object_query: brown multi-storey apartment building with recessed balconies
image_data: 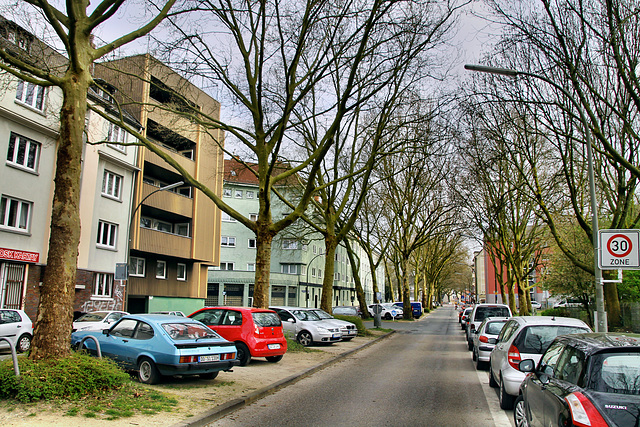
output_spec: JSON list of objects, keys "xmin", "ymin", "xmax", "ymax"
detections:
[{"xmin": 95, "ymin": 55, "xmax": 224, "ymax": 313}]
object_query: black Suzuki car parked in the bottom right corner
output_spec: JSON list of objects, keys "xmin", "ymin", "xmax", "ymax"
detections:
[{"xmin": 513, "ymin": 333, "xmax": 640, "ymax": 426}]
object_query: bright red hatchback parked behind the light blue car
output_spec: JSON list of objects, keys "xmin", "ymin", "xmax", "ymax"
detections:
[{"xmin": 188, "ymin": 307, "xmax": 287, "ymax": 366}]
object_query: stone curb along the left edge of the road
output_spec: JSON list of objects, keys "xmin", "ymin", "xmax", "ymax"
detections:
[{"xmin": 172, "ymin": 331, "xmax": 396, "ymax": 427}]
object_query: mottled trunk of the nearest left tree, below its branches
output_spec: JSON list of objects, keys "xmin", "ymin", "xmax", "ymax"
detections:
[{"xmin": 30, "ymin": 75, "xmax": 91, "ymax": 360}]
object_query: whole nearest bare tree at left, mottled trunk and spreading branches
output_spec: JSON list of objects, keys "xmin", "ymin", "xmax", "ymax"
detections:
[{"xmin": 0, "ymin": 0, "xmax": 175, "ymax": 359}]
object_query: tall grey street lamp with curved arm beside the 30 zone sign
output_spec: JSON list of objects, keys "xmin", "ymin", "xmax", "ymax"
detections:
[{"xmin": 464, "ymin": 64, "xmax": 608, "ymax": 332}]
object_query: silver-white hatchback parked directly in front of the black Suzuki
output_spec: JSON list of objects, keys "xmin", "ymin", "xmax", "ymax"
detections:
[{"xmin": 489, "ymin": 316, "xmax": 591, "ymax": 409}]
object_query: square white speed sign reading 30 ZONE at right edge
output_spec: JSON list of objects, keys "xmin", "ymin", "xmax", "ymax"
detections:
[{"xmin": 598, "ymin": 230, "xmax": 640, "ymax": 270}]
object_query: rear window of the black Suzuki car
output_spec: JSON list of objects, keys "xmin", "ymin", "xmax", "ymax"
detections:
[{"xmin": 592, "ymin": 353, "xmax": 640, "ymax": 395}]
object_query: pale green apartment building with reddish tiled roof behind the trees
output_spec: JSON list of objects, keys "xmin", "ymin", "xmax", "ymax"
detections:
[{"xmin": 205, "ymin": 160, "xmax": 384, "ymax": 307}]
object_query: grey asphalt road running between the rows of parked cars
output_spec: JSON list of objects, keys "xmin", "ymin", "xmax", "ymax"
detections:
[{"xmin": 209, "ymin": 306, "xmax": 512, "ymax": 427}]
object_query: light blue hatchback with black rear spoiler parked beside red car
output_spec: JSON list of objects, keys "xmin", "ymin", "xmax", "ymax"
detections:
[{"xmin": 71, "ymin": 314, "xmax": 238, "ymax": 384}]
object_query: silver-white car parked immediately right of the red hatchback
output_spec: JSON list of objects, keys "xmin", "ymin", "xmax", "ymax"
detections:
[{"xmin": 269, "ymin": 307, "xmax": 342, "ymax": 347}]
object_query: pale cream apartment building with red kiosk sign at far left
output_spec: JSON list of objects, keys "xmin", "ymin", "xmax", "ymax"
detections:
[{"xmin": 0, "ymin": 18, "xmax": 139, "ymax": 319}]
